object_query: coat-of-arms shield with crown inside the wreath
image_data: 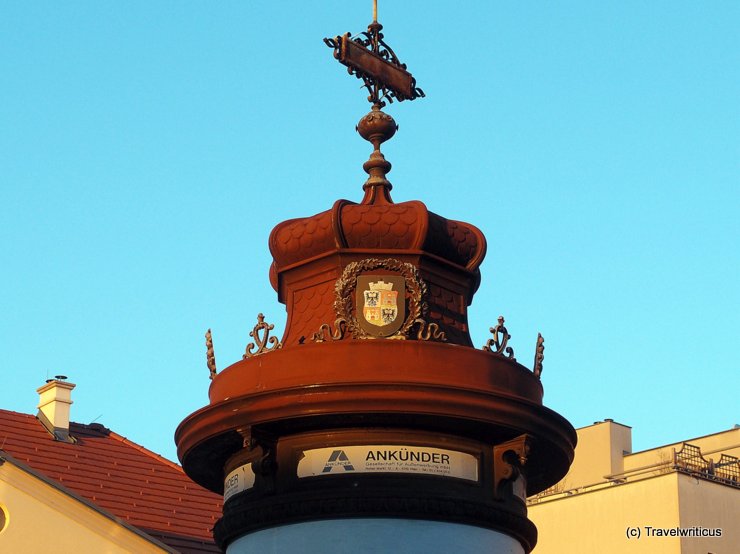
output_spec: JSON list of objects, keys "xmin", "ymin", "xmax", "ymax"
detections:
[{"xmin": 356, "ymin": 275, "xmax": 406, "ymax": 337}]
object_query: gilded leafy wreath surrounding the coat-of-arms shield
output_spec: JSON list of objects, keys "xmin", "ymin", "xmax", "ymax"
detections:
[{"xmin": 334, "ymin": 258, "xmax": 427, "ymax": 340}]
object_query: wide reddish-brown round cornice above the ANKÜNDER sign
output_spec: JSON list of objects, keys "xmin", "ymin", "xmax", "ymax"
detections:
[{"xmin": 175, "ymin": 340, "xmax": 576, "ymax": 493}]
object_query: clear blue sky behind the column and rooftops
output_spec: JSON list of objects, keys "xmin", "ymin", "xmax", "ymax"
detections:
[{"xmin": 0, "ymin": 0, "xmax": 740, "ymax": 458}]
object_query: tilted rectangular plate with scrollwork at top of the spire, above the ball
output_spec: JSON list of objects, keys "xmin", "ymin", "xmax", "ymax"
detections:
[{"xmin": 324, "ymin": 14, "xmax": 424, "ymax": 108}]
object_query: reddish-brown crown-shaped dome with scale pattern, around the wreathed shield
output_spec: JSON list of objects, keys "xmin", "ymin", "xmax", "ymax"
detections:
[{"xmin": 270, "ymin": 194, "xmax": 486, "ymax": 346}]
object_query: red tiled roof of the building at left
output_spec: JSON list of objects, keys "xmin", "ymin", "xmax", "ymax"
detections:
[{"xmin": 0, "ymin": 410, "xmax": 222, "ymax": 554}]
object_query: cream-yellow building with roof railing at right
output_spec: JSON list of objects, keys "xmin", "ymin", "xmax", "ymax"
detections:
[{"xmin": 528, "ymin": 420, "xmax": 740, "ymax": 554}]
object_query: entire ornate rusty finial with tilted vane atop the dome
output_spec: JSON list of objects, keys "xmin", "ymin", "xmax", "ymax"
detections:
[{"xmin": 324, "ymin": 0, "xmax": 424, "ymax": 204}]
